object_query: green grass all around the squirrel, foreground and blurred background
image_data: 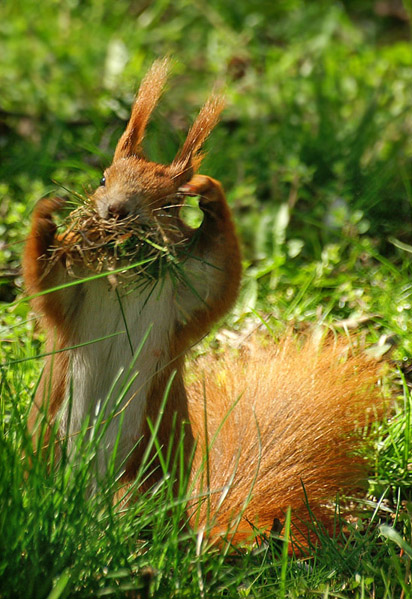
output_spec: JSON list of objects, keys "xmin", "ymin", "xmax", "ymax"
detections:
[{"xmin": 0, "ymin": 0, "xmax": 412, "ymax": 599}]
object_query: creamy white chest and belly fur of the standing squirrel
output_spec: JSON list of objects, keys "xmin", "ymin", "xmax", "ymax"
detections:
[{"xmin": 61, "ymin": 279, "xmax": 175, "ymax": 473}]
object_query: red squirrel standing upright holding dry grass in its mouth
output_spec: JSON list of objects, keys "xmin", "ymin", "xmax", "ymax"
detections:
[{"xmin": 23, "ymin": 60, "xmax": 384, "ymax": 536}]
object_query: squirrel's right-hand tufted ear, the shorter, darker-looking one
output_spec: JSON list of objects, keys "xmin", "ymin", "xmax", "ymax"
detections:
[{"xmin": 172, "ymin": 94, "xmax": 225, "ymax": 172}]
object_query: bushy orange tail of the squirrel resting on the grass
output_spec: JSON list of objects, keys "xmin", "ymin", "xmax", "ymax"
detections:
[{"xmin": 189, "ymin": 338, "xmax": 383, "ymax": 538}]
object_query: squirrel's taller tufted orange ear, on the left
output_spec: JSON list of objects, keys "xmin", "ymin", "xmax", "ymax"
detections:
[{"xmin": 113, "ymin": 58, "xmax": 170, "ymax": 162}]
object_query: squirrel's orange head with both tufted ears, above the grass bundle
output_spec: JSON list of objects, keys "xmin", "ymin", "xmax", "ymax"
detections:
[{"xmin": 91, "ymin": 59, "xmax": 224, "ymax": 220}]
